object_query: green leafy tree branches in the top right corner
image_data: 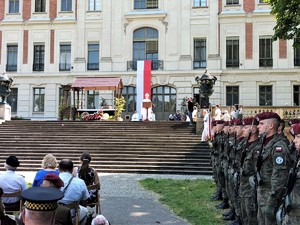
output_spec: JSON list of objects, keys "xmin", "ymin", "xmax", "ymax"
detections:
[{"xmin": 268, "ymin": 0, "xmax": 300, "ymax": 47}]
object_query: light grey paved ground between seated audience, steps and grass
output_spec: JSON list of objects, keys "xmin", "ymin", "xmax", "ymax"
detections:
[{"xmin": 21, "ymin": 172, "xmax": 210, "ymax": 225}]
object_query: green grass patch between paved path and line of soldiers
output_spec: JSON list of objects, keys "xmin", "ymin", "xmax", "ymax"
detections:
[{"xmin": 140, "ymin": 178, "xmax": 226, "ymax": 225}]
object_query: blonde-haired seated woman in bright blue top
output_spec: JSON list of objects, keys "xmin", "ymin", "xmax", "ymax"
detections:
[{"xmin": 32, "ymin": 154, "xmax": 58, "ymax": 187}]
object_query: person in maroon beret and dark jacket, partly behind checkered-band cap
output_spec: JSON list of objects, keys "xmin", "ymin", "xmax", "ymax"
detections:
[{"xmin": 41, "ymin": 174, "xmax": 72, "ymax": 225}]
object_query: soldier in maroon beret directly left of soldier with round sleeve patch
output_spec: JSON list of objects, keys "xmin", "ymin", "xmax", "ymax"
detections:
[{"xmin": 239, "ymin": 117, "xmax": 261, "ymax": 225}]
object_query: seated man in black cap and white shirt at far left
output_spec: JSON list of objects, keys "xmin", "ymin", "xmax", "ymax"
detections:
[{"xmin": 0, "ymin": 155, "xmax": 27, "ymax": 211}]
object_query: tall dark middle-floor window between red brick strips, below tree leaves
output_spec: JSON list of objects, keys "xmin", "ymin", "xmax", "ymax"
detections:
[{"xmin": 259, "ymin": 38, "xmax": 273, "ymax": 67}]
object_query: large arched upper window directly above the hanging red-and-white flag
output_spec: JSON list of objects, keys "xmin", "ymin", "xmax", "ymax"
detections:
[{"xmin": 133, "ymin": 27, "xmax": 160, "ymax": 70}]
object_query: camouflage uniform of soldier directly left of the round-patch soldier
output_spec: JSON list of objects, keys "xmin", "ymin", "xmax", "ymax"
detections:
[{"xmin": 239, "ymin": 139, "xmax": 261, "ymax": 225}]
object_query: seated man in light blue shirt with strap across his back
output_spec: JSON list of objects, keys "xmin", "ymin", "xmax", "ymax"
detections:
[{"xmin": 58, "ymin": 159, "xmax": 90, "ymax": 225}]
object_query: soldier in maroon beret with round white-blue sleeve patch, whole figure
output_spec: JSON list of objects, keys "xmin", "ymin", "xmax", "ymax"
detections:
[{"xmin": 256, "ymin": 112, "xmax": 292, "ymax": 225}]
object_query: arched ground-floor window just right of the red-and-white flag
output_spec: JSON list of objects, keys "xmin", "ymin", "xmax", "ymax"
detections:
[{"xmin": 152, "ymin": 86, "xmax": 176, "ymax": 120}]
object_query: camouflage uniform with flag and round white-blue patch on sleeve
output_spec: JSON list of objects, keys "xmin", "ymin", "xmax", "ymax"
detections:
[{"xmin": 257, "ymin": 134, "xmax": 292, "ymax": 225}]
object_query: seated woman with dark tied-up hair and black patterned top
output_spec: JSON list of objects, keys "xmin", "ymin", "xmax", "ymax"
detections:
[{"xmin": 74, "ymin": 152, "xmax": 100, "ymax": 206}]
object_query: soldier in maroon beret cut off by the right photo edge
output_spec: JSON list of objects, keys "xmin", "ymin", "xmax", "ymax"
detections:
[{"xmin": 282, "ymin": 123, "xmax": 300, "ymax": 225}]
